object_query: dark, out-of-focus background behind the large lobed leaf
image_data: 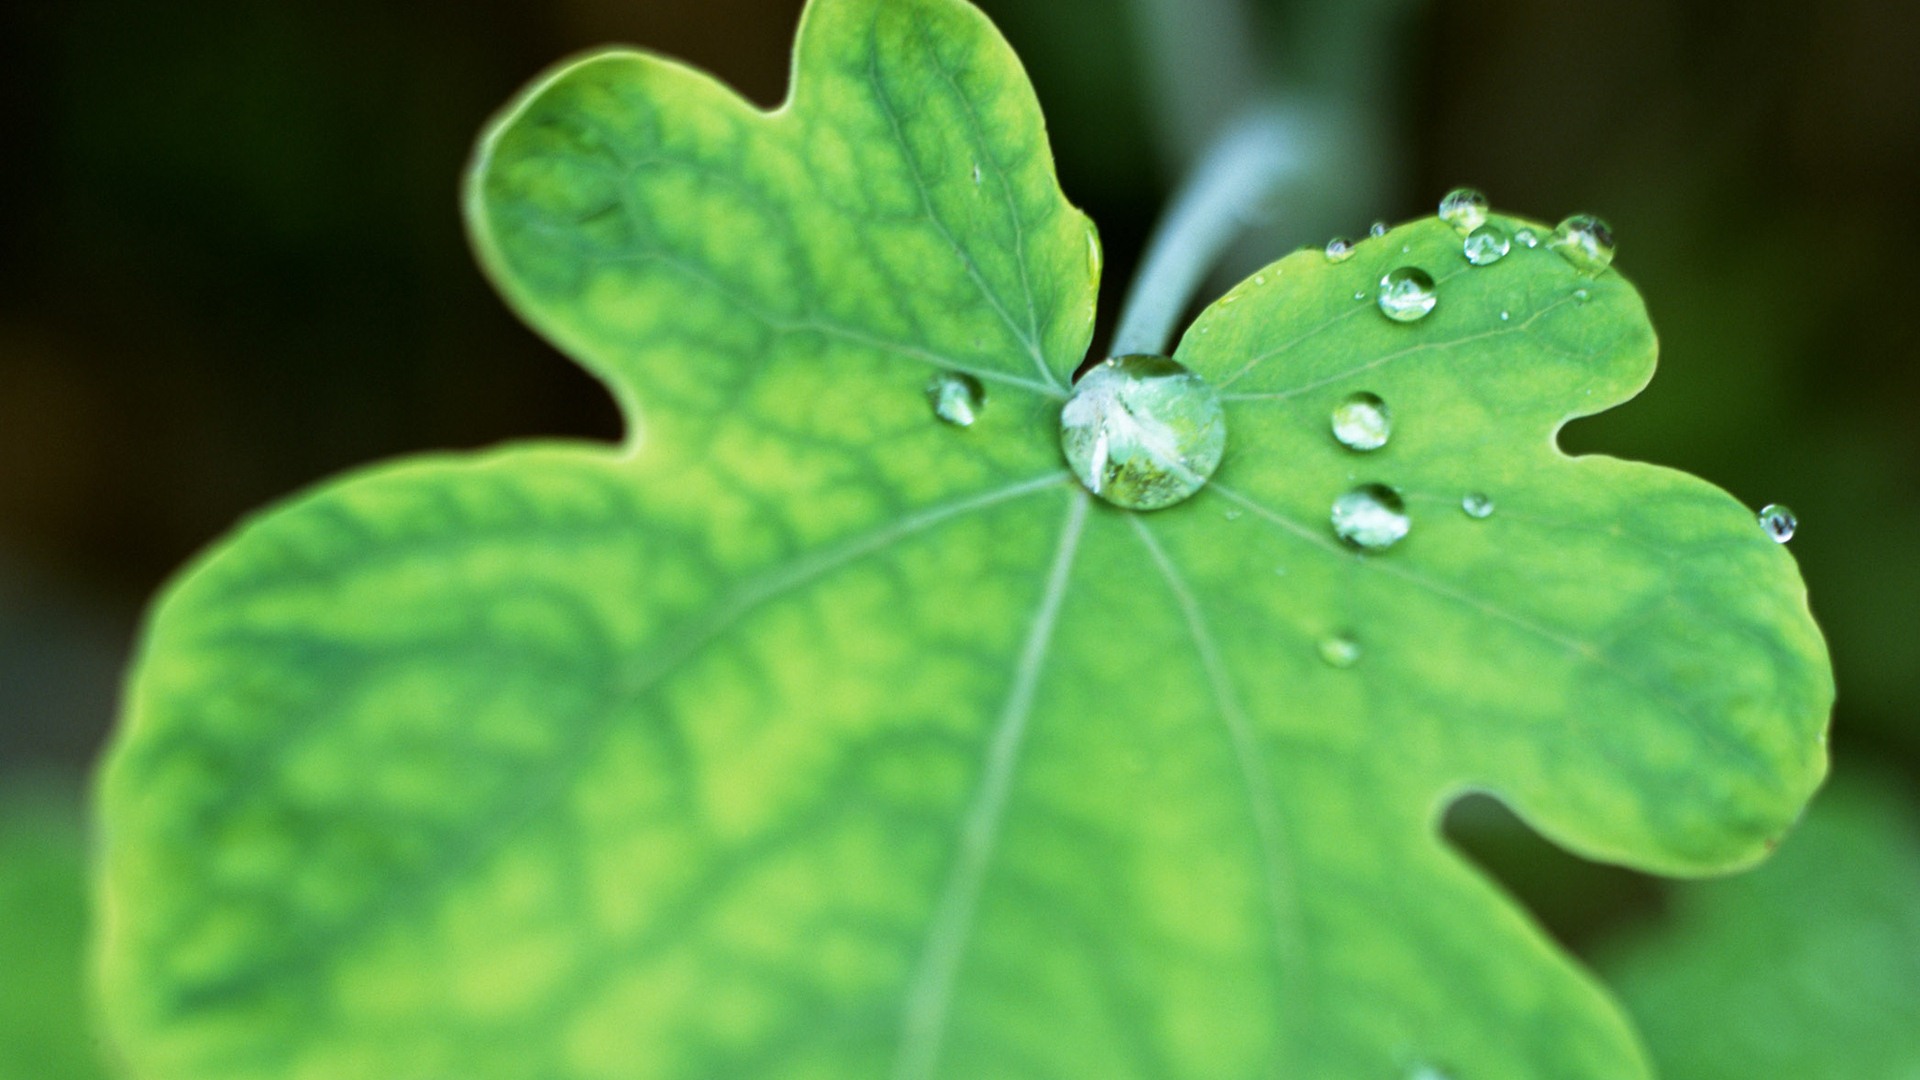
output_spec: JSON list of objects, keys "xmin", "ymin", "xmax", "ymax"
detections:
[{"xmin": 0, "ymin": 0, "xmax": 1920, "ymax": 938}]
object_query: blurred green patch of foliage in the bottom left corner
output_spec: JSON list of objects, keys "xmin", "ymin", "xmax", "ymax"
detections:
[{"xmin": 0, "ymin": 774, "xmax": 106, "ymax": 1080}]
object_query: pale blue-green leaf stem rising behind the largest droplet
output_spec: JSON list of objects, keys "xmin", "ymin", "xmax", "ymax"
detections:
[{"xmin": 1112, "ymin": 104, "xmax": 1311, "ymax": 356}]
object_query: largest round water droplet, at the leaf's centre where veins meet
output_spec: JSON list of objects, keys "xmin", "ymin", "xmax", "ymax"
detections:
[{"xmin": 1060, "ymin": 356, "xmax": 1227, "ymax": 509}]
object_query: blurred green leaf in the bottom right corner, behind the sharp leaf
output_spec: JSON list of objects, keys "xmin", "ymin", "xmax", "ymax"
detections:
[{"xmin": 1599, "ymin": 771, "xmax": 1920, "ymax": 1080}]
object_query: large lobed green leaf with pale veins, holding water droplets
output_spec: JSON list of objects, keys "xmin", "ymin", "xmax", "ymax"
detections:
[{"xmin": 90, "ymin": 0, "xmax": 1832, "ymax": 1080}]
